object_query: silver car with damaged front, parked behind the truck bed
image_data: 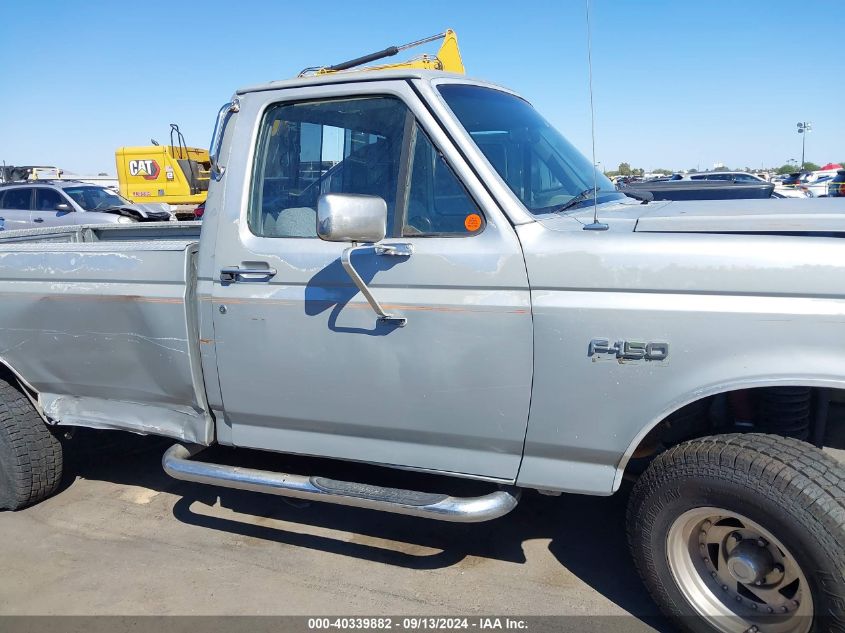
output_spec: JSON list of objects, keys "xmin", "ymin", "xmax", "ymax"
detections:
[{"xmin": 0, "ymin": 180, "xmax": 173, "ymax": 231}]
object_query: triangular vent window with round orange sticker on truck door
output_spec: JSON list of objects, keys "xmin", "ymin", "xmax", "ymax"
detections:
[{"xmin": 402, "ymin": 127, "xmax": 484, "ymax": 236}]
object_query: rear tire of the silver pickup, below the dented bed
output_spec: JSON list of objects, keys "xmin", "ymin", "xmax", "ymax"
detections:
[{"xmin": 0, "ymin": 376, "xmax": 62, "ymax": 510}]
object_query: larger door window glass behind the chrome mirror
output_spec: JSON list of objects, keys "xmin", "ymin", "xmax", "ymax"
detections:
[{"xmin": 248, "ymin": 97, "xmax": 408, "ymax": 237}]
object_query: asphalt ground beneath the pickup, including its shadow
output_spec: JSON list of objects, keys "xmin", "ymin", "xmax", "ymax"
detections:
[{"xmin": 0, "ymin": 431, "xmax": 671, "ymax": 631}]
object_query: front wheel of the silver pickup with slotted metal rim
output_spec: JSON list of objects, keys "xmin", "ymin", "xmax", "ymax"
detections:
[{"xmin": 628, "ymin": 434, "xmax": 845, "ymax": 633}]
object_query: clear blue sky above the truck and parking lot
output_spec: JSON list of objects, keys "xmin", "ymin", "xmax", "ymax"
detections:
[{"xmin": 0, "ymin": 0, "xmax": 845, "ymax": 173}]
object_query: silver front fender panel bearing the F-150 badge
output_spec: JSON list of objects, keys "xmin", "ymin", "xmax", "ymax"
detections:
[{"xmin": 517, "ymin": 226, "xmax": 845, "ymax": 495}]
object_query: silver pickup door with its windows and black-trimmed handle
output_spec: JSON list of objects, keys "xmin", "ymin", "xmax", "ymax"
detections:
[{"xmin": 211, "ymin": 81, "xmax": 532, "ymax": 479}]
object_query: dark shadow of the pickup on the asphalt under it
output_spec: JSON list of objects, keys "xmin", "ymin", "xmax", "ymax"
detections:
[{"xmin": 63, "ymin": 430, "xmax": 673, "ymax": 631}]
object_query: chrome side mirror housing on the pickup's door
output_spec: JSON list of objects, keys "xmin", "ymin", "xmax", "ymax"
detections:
[{"xmin": 317, "ymin": 193, "xmax": 387, "ymax": 243}]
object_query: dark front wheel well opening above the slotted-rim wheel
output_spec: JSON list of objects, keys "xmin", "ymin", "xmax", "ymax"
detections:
[{"xmin": 625, "ymin": 385, "xmax": 845, "ymax": 477}]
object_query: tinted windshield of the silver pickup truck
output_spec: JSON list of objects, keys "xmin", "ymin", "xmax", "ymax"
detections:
[{"xmin": 437, "ymin": 84, "xmax": 625, "ymax": 214}]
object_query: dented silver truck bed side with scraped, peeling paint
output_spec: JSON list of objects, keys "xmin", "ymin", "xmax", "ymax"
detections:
[{"xmin": 0, "ymin": 222, "xmax": 212, "ymax": 443}]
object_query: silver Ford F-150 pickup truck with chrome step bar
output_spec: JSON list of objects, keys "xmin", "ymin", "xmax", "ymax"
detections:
[{"xmin": 0, "ymin": 66, "xmax": 845, "ymax": 633}]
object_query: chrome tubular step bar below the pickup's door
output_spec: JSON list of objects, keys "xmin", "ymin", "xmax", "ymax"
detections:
[{"xmin": 161, "ymin": 444, "xmax": 520, "ymax": 523}]
